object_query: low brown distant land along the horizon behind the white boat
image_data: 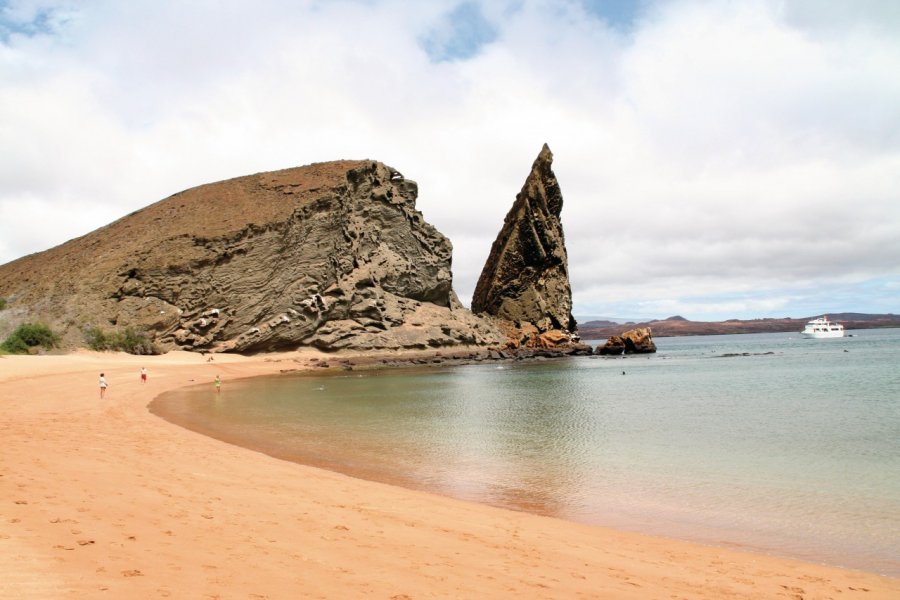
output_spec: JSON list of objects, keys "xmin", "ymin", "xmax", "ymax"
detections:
[{"xmin": 578, "ymin": 313, "xmax": 900, "ymax": 340}]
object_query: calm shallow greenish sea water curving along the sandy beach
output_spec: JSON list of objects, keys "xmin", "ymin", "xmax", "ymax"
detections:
[{"xmin": 153, "ymin": 329, "xmax": 900, "ymax": 576}]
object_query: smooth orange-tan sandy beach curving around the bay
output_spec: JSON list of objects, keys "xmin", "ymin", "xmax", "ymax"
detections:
[{"xmin": 0, "ymin": 352, "xmax": 900, "ymax": 600}]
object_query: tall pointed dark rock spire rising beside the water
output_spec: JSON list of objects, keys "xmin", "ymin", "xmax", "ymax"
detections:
[{"xmin": 472, "ymin": 144, "xmax": 576, "ymax": 339}]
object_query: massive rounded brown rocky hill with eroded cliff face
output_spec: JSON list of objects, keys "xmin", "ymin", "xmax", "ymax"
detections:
[{"xmin": 0, "ymin": 161, "xmax": 504, "ymax": 352}]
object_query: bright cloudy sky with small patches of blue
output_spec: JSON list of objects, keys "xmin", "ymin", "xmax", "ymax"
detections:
[{"xmin": 0, "ymin": 0, "xmax": 900, "ymax": 320}]
